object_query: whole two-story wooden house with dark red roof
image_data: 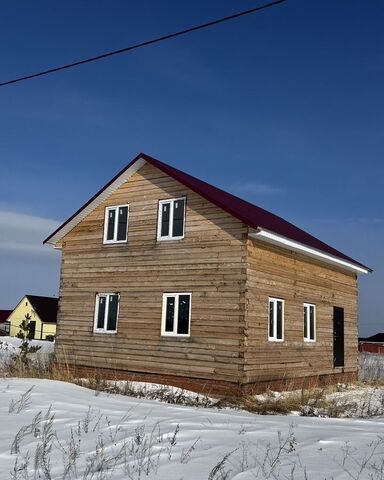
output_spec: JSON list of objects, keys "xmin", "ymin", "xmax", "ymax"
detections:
[{"xmin": 45, "ymin": 154, "xmax": 370, "ymax": 393}]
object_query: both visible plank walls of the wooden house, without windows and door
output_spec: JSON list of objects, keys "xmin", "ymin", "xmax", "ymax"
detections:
[{"xmin": 56, "ymin": 164, "xmax": 357, "ymax": 385}]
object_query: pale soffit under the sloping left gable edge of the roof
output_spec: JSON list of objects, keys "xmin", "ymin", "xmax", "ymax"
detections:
[{"xmin": 47, "ymin": 158, "xmax": 147, "ymax": 245}]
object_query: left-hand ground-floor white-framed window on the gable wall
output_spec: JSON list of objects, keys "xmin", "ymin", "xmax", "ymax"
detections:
[{"xmin": 93, "ymin": 293, "xmax": 120, "ymax": 333}]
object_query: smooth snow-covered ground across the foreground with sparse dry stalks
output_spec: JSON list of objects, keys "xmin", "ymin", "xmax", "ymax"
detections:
[{"xmin": 0, "ymin": 379, "xmax": 384, "ymax": 480}]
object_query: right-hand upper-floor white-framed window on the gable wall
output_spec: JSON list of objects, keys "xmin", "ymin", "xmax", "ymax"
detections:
[{"xmin": 157, "ymin": 197, "xmax": 185, "ymax": 240}]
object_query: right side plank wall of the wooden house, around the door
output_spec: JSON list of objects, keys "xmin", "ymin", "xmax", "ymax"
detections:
[{"xmin": 244, "ymin": 239, "xmax": 357, "ymax": 384}]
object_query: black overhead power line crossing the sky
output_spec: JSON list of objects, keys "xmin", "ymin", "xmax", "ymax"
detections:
[{"xmin": 0, "ymin": 0, "xmax": 287, "ymax": 87}]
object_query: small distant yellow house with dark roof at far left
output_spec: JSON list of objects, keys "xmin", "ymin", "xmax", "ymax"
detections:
[{"xmin": 8, "ymin": 295, "xmax": 58, "ymax": 340}]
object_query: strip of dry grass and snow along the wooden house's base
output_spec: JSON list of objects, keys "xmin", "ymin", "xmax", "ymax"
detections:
[{"xmin": 0, "ymin": 346, "xmax": 384, "ymax": 417}]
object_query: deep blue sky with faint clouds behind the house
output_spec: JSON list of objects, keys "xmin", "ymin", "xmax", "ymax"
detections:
[{"xmin": 0, "ymin": 0, "xmax": 384, "ymax": 335}]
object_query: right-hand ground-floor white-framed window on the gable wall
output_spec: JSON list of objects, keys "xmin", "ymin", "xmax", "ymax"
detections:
[{"xmin": 161, "ymin": 293, "xmax": 192, "ymax": 337}]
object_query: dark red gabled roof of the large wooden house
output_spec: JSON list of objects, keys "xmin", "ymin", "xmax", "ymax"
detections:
[{"xmin": 44, "ymin": 153, "xmax": 371, "ymax": 270}]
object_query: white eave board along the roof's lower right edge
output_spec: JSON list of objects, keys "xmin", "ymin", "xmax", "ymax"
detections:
[{"xmin": 249, "ymin": 228, "xmax": 369, "ymax": 273}]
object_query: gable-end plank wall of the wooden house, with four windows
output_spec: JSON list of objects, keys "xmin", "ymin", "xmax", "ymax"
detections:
[{"xmin": 57, "ymin": 164, "xmax": 248, "ymax": 383}]
